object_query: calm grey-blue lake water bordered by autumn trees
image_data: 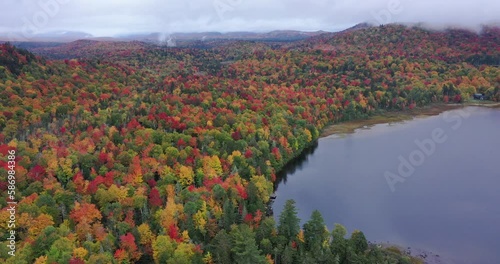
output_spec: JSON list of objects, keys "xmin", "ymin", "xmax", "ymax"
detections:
[{"xmin": 273, "ymin": 107, "xmax": 500, "ymax": 264}]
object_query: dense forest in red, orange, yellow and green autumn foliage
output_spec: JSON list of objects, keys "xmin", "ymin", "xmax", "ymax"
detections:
[{"xmin": 0, "ymin": 25, "xmax": 500, "ymax": 264}]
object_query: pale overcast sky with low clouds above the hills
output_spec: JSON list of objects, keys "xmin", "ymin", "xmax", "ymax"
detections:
[{"xmin": 0, "ymin": 0, "xmax": 500, "ymax": 36}]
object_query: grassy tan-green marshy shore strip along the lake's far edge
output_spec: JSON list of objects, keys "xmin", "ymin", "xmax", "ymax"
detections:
[{"xmin": 319, "ymin": 102, "xmax": 500, "ymax": 138}]
